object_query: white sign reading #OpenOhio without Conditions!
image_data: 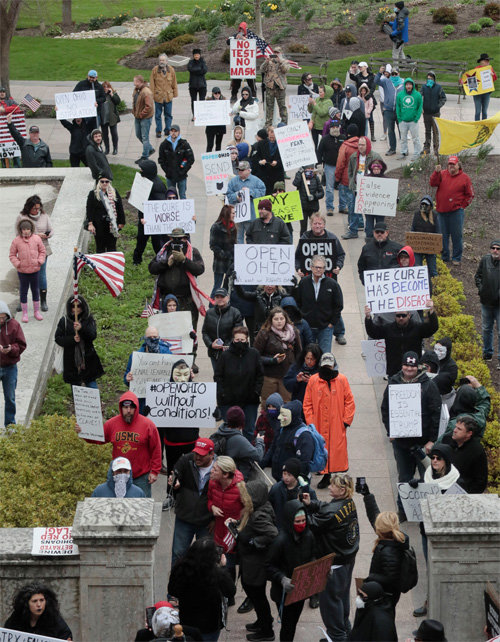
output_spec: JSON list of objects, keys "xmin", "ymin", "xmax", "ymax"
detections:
[{"xmin": 146, "ymin": 381, "xmax": 217, "ymax": 428}]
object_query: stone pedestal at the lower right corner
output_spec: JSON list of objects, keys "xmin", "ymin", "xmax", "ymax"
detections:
[{"xmin": 422, "ymin": 495, "xmax": 500, "ymax": 642}]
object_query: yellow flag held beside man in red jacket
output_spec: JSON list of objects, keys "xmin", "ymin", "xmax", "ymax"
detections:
[{"xmin": 435, "ymin": 111, "xmax": 500, "ymax": 154}]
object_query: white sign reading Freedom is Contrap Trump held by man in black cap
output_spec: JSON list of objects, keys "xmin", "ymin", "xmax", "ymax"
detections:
[{"xmin": 389, "ymin": 383, "xmax": 422, "ymax": 439}]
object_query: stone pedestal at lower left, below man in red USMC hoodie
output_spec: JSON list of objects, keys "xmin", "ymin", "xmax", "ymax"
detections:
[{"xmin": 73, "ymin": 498, "xmax": 161, "ymax": 642}]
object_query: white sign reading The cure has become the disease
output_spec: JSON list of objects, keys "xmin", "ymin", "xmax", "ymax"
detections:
[{"xmin": 363, "ymin": 265, "xmax": 430, "ymax": 314}]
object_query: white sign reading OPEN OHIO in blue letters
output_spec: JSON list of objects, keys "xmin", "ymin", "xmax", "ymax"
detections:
[{"xmin": 234, "ymin": 245, "xmax": 295, "ymax": 285}]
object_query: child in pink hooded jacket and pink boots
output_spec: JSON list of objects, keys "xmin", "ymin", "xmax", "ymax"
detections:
[{"xmin": 9, "ymin": 219, "xmax": 47, "ymax": 323}]
